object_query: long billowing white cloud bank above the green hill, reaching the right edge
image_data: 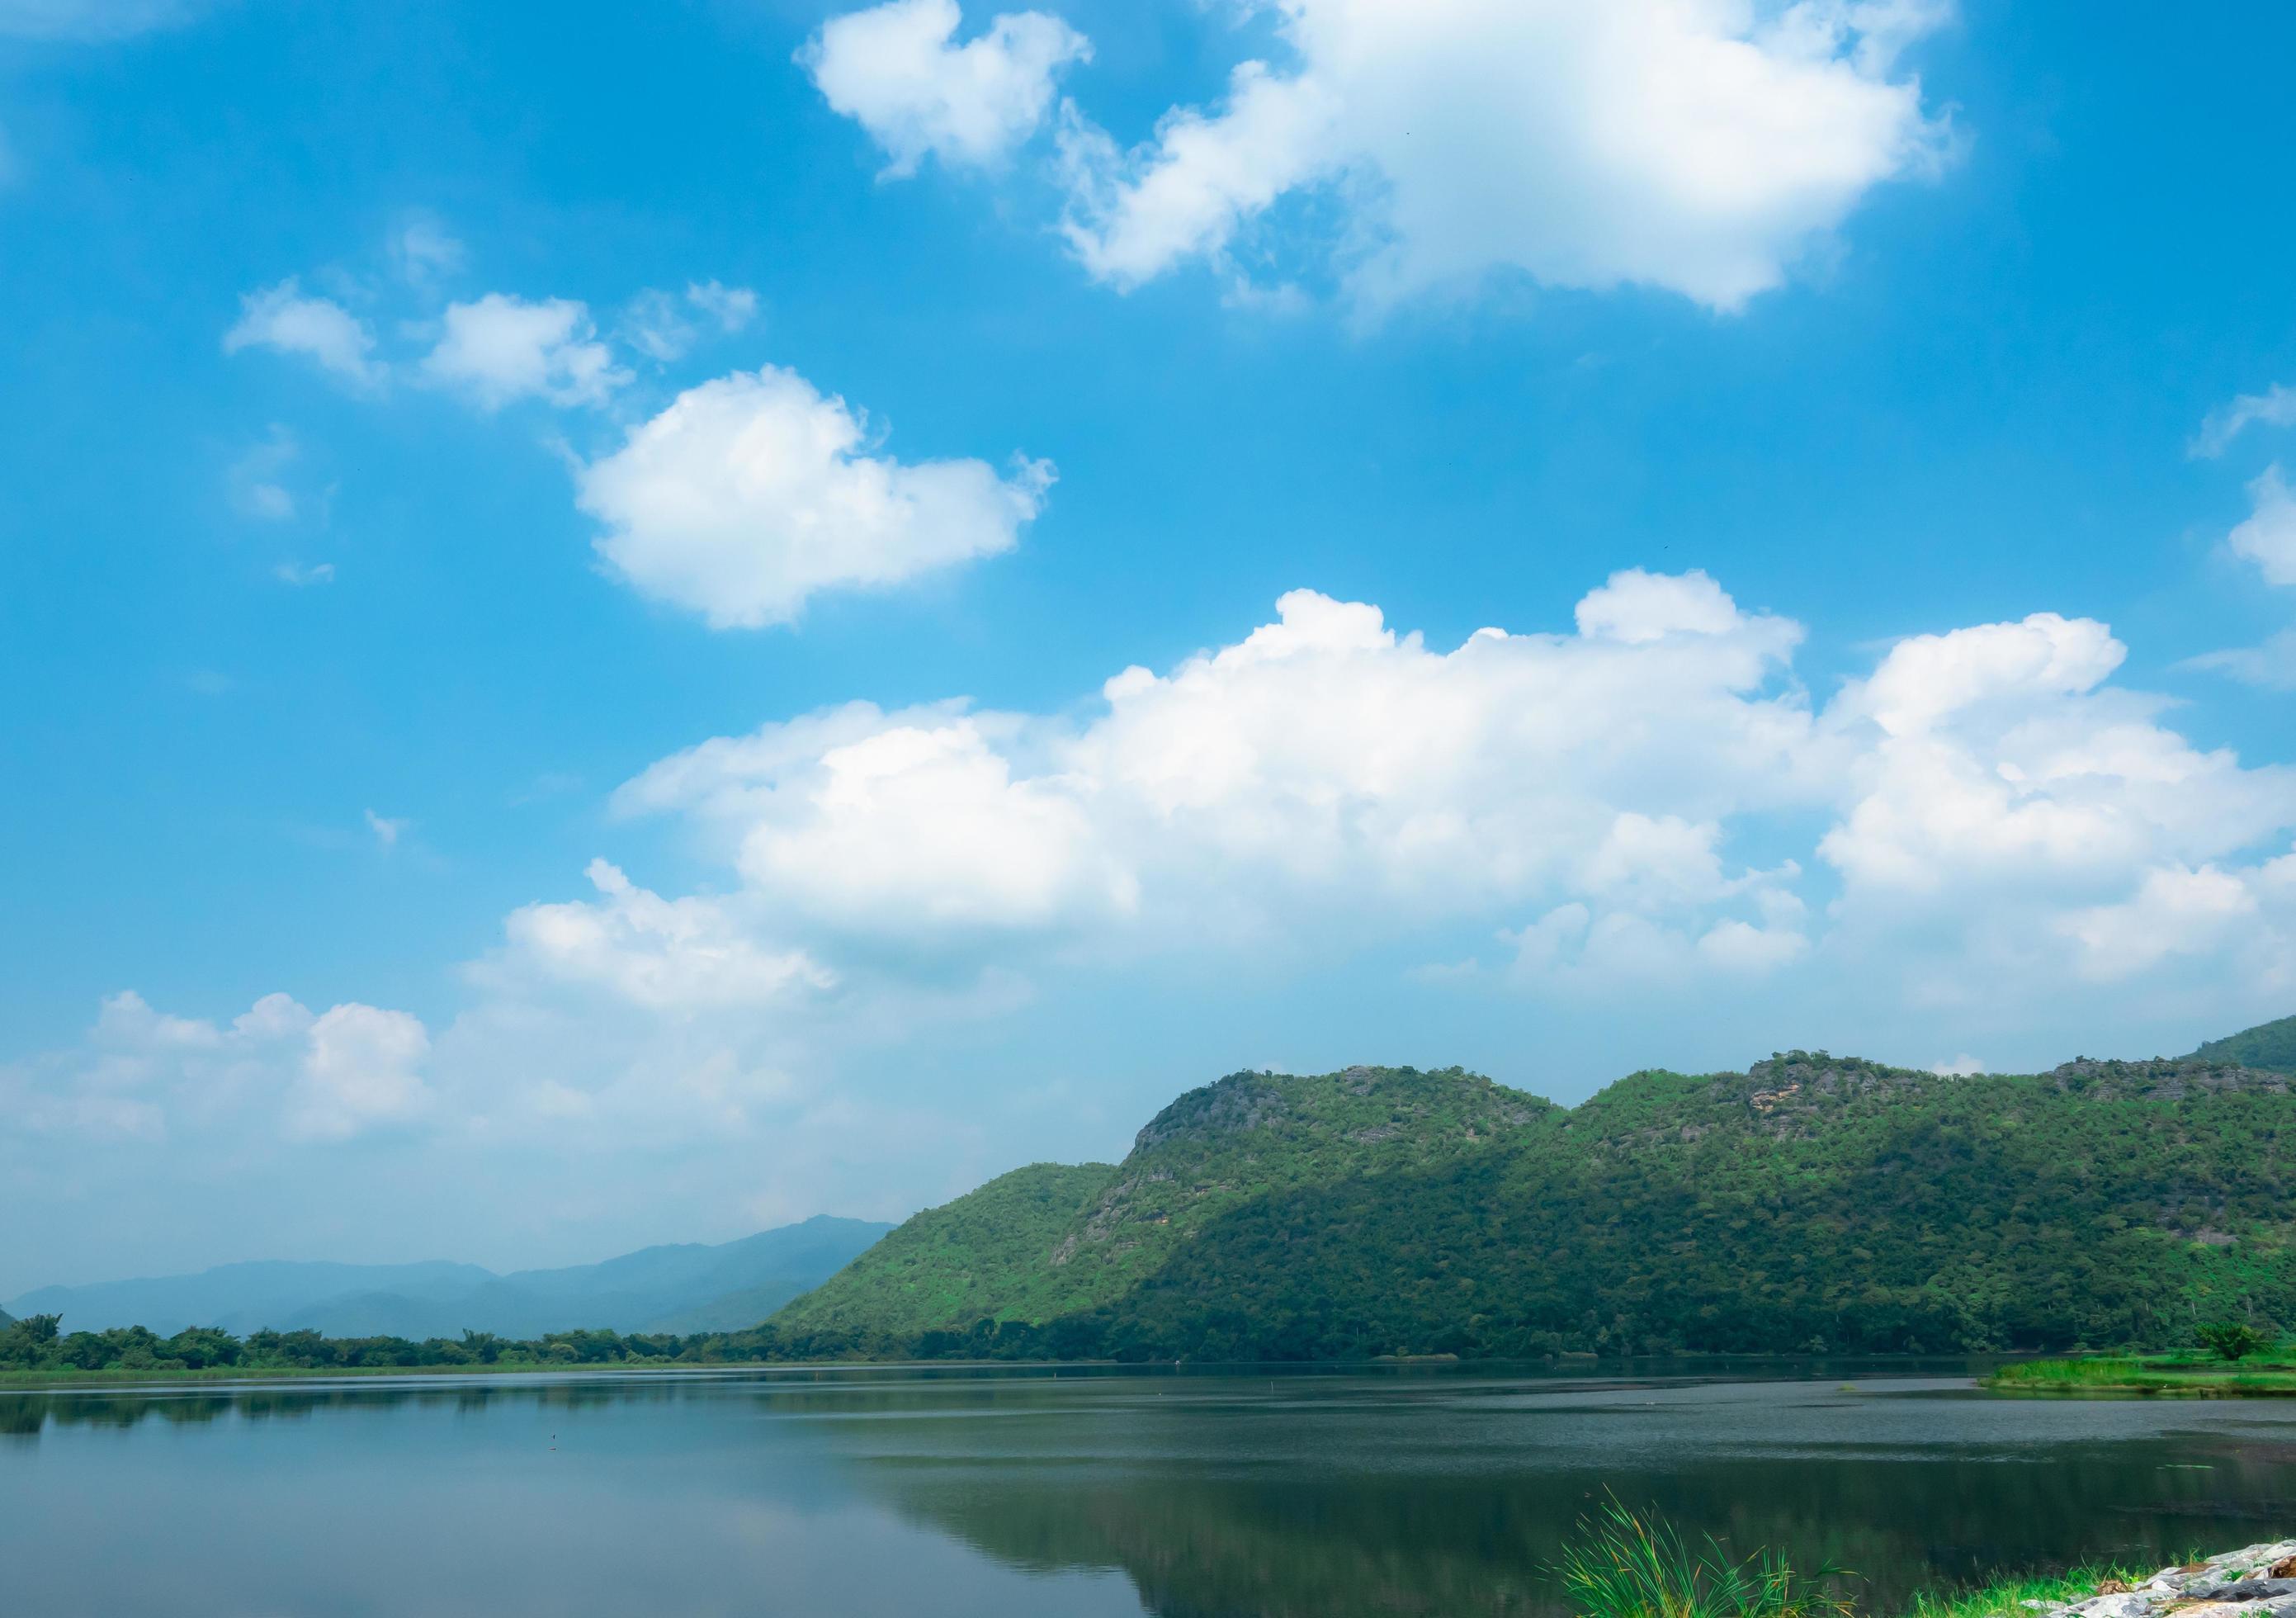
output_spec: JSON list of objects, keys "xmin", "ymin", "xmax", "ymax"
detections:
[{"xmin": 616, "ymin": 571, "xmax": 2296, "ymax": 982}]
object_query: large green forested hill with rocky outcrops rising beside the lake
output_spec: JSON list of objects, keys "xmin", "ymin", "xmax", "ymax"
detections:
[{"xmin": 769, "ymin": 1028, "xmax": 2296, "ymax": 1359}]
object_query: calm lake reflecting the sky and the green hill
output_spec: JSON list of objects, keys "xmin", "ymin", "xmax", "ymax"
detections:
[{"xmin": 0, "ymin": 1368, "xmax": 2296, "ymax": 1618}]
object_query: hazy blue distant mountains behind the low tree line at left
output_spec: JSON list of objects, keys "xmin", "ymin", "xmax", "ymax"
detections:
[{"xmin": 0, "ymin": 1214, "xmax": 891, "ymax": 1341}]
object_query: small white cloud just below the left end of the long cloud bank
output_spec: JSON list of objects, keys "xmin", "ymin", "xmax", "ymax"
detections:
[{"xmin": 498, "ymin": 861, "xmax": 836, "ymax": 1012}]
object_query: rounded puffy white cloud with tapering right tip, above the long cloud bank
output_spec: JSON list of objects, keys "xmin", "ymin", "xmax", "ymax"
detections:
[{"xmin": 579, "ymin": 365, "xmax": 1051, "ymax": 629}]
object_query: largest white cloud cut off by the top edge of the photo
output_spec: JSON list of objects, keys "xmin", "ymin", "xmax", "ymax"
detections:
[{"xmin": 1063, "ymin": 0, "xmax": 1947, "ymax": 310}]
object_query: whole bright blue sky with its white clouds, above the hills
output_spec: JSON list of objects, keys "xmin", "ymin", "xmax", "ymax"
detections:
[{"xmin": 0, "ymin": 0, "xmax": 2296, "ymax": 1294}]
